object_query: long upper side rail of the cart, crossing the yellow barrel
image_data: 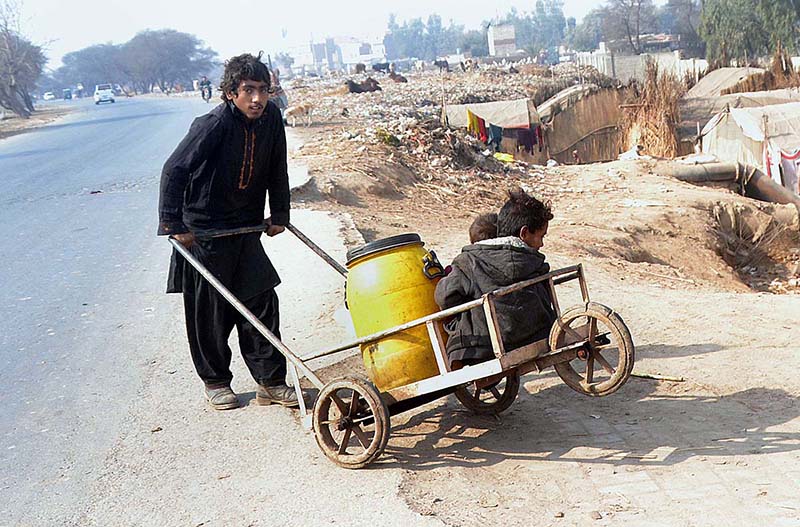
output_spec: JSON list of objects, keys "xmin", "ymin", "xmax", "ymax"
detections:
[{"xmin": 304, "ymin": 264, "xmax": 583, "ymax": 361}]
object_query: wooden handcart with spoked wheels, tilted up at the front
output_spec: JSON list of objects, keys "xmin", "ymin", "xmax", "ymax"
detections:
[{"xmin": 170, "ymin": 220, "xmax": 634, "ymax": 469}]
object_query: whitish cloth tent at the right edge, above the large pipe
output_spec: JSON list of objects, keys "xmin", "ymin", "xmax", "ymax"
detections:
[{"xmin": 701, "ymin": 102, "xmax": 800, "ymax": 194}]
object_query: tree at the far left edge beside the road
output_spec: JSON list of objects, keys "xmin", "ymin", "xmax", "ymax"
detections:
[{"xmin": 0, "ymin": 0, "xmax": 47, "ymax": 118}]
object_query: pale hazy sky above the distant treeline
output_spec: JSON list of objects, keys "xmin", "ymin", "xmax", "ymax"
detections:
[{"xmin": 22, "ymin": 0, "xmax": 612, "ymax": 68}]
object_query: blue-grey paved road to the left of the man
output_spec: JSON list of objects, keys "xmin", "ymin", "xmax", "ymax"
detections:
[{"xmin": 0, "ymin": 97, "xmax": 307, "ymax": 525}]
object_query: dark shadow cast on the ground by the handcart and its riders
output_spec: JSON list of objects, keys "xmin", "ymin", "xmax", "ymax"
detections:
[{"xmin": 386, "ymin": 379, "xmax": 800, "ymax": 470}]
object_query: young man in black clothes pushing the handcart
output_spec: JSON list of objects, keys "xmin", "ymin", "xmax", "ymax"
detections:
[{"xmin": 158, "ymin": 54, "xmax": 298, "ymax": 410}]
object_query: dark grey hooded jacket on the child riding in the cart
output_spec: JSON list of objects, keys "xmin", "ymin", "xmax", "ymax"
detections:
[{"xmin": 435, "ymin": 237, "xmax": 556, "ymax": 362}]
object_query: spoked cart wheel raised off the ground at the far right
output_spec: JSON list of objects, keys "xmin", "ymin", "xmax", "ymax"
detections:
[{"xmin": 550, "ymin": 302, "xmax": 634, "ymax": 397}]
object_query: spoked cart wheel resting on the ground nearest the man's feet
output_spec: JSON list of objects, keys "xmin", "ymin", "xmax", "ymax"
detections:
[{"xmin": 312, "ymin": 375, "xmax": 390, "ymax": 468}]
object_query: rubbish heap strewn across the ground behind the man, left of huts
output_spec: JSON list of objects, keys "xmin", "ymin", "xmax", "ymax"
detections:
[{"xmin": 289, "ymin": 64, "xmax": 612, "ymax": 205}]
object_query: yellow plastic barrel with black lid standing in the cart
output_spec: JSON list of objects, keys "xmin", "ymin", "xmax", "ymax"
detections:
[{"xmin": 345, "ymin": 234, "xmax": 444, "ymax": 391}]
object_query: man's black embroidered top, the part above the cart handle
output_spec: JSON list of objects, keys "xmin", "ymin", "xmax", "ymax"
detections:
[{"xmin": 158, "ymin": 102, "xmax": 289, "ymax": 235}]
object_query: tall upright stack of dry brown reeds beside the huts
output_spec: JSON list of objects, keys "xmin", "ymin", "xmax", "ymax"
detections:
[{"xmin": 621, "ymin": 60, "xmax": 686, "ymax": 158}]
